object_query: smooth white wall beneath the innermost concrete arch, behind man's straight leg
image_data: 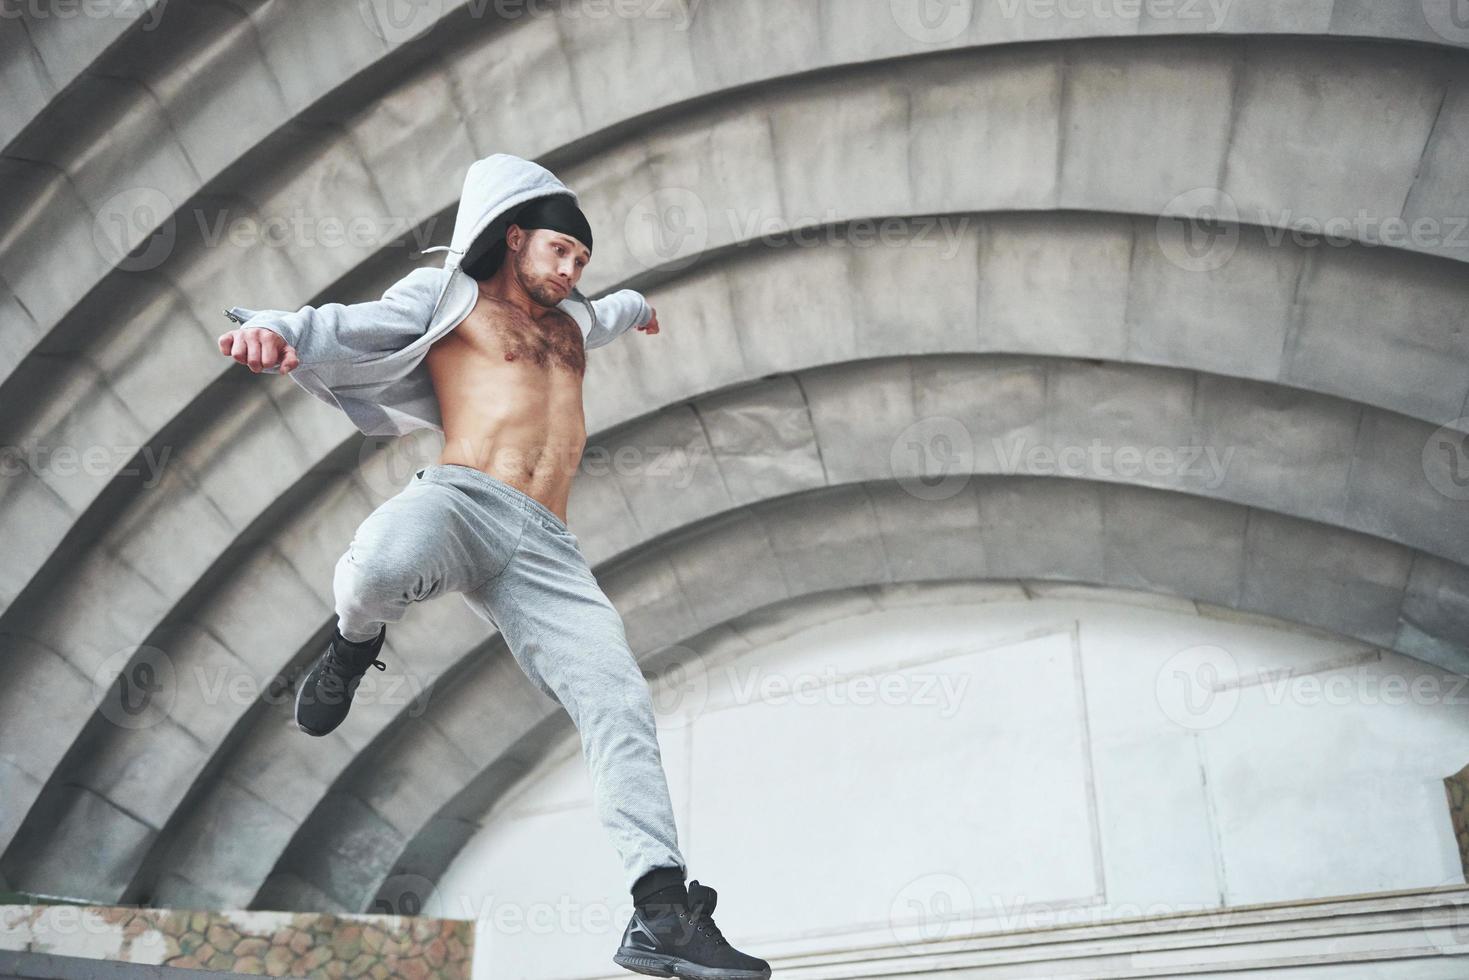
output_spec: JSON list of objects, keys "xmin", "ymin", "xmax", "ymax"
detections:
[{"xmin": 433, "ymin": 585, "xmax": 1469, "ymax": 977}]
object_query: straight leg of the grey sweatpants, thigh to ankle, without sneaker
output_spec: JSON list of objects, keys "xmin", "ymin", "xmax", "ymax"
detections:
[{"xmin": 464, "ymin": 511, "xmax": 687, "ymax": 893}]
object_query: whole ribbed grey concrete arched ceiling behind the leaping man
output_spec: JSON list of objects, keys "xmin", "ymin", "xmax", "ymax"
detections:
[{"xmin": 0, "ymin": 0, "xmax": 1469, "ymax": 909}]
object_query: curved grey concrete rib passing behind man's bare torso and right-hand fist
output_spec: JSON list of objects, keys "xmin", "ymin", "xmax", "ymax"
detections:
[{"xmin": 0, "ymin": 205, "xmax": 1469, "ymax": 839}]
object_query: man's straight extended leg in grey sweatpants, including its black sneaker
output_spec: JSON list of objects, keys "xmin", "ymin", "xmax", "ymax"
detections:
[{"xmin": 408, "ymin": 467, "xmax": 770, "ymax": 980}]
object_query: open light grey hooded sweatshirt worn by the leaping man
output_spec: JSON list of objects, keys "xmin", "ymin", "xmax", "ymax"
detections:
[{"xmin": 225, "ymin": 153, "xmax": 652, "ymax": 435}]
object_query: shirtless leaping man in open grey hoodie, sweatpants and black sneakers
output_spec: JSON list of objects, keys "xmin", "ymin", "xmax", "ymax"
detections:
[{"xmin": 219, "ymin": 154, "xmax": 770, "ymax": 980}]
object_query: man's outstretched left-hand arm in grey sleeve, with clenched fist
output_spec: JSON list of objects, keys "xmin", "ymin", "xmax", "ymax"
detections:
[{"xmin": 219, "ymin": 267, "xmax": 444, "ymax": 373}]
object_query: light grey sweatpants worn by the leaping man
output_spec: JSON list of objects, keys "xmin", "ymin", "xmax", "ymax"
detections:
[{"xmin": 333, "ymin": 464, "xmax": 687, "ymax": 890}]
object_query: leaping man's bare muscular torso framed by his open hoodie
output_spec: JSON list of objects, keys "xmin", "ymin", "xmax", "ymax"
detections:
[{"xmin": 425, "ymin": 295, "xmax": 586, "ymax": 522}]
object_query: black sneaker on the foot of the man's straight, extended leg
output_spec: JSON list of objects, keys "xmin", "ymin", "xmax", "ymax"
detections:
[{"xmin": 613, "ymin": 880, "xmax": 770, "ymax": 980}]
